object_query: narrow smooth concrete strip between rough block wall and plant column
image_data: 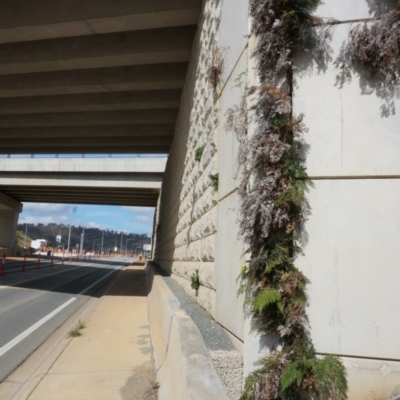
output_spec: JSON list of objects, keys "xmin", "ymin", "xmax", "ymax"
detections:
[{"xmin": 215, "ymin": 0, "xmax": 249, "ymax": 343}]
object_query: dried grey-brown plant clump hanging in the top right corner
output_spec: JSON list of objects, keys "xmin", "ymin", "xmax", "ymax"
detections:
[{"xmin": 335, "ymin": 0, "xmax": 400, "ymax": 116}]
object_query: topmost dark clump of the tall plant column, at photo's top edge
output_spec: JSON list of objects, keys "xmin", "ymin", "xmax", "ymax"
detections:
[{"xmin": 250, "ymin": 0, "xmax": 331, "ymax": 86}]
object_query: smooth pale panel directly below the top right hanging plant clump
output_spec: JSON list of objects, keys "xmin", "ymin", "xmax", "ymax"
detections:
[{"xmin": 294, "ymin": 22, "xmax": 400, "ymax": 177}]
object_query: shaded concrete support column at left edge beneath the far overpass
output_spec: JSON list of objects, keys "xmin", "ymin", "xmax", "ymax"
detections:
[{"xmin": 0, "ymin": 192, "xmax": 22, "ymax": 250}]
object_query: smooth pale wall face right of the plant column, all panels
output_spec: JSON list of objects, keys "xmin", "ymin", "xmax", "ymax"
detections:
[{"xmin": 294, "ymin": 0, "xmax": 400, "ymax": 400}]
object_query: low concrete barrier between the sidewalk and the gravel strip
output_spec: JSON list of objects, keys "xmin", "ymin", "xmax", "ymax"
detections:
[{"xmin": 146, "ymin": 261, "xmax": 229, "ymax": 400}]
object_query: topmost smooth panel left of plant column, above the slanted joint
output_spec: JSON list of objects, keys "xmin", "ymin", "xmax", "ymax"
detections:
[{"xmin": 218, "ymin": 0, "xmax": 249, "ymax": 84}]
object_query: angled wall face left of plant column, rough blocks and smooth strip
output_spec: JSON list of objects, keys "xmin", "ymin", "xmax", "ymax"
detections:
[{"xmin": 155, "ymin": 0, "xmax": 248, "ymax": 332}]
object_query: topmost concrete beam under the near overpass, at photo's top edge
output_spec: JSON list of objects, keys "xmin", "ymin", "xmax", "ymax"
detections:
[{"xmin": 0, "ymin": 0, "xmax": 202, "ymax": 43}]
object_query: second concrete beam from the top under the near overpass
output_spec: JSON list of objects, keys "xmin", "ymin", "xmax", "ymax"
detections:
[{"xmin": 0, "ymin": 26, "xmax": 196, "ymax": 74}]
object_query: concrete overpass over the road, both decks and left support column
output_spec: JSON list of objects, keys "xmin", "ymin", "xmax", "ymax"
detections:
[{"xmin": 0, "ymin": 0, "xmax": 202, "ymax": 253}]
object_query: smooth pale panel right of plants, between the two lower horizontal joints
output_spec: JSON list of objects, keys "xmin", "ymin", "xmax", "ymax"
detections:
[{"xmin": 297, "ymin": 179, "xmax": 400, "ymax": 360}]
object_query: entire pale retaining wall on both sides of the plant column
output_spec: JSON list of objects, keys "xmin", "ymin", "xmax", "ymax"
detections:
[{"xmin": 155, "ymin": 0, "xmax": 400, "ymax": 400}]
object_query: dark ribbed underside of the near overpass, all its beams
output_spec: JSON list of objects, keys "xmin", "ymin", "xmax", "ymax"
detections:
[{"xmin": 0, "ymin": 0, "xmax": 202, "ymax": 154}]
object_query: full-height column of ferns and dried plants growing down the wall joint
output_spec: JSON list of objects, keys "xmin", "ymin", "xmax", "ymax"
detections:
[{"xmin": 227, "ymin": 0, "xmax": 347, "ymax": 400}]
